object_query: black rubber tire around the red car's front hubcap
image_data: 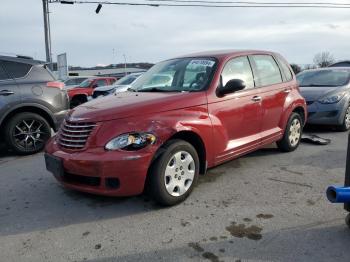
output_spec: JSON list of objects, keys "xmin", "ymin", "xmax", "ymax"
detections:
[{"xmin": 149, "ymin": 139, "xmax": 199, "ymax": 206}]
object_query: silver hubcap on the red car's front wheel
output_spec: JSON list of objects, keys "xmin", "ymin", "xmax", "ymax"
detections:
[{"xmin": 164, "ymin": 151, "xmax": 196, "ymax": 197}]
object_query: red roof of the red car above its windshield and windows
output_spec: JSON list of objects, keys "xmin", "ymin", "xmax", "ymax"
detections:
[{"xmin": 176, "ymin": 49, "xmax": 276, "ymax": 59}]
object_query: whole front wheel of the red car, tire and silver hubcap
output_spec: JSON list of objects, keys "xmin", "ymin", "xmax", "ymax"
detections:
[{"xmin": 147, "ymin": 139, "xmax": 199, "ymax": 206}]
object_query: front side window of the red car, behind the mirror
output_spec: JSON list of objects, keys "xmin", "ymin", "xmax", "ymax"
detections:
[{"xmin": 221, "ymin": 56, "xmax": 254, "ymax": 89}]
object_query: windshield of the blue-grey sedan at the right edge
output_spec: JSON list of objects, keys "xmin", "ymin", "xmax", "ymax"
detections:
[{"xmin": 297, "ymin": 69, "xmax": 350, "ymax": 86}]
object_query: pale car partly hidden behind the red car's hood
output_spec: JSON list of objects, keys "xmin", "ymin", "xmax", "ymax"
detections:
[{"xmin": 92, "ymin": 73, "xmax": 143, "ymax": 98}]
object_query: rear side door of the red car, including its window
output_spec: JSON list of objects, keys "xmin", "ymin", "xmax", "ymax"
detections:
[{"xmin": 249, "ymin": 54, "xmax": 290, "ymax": 144}]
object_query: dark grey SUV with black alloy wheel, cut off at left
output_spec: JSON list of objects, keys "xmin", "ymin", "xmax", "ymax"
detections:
[{"xmin": 0, "ymin": 56, "xmax": 69, "ymax": 154}]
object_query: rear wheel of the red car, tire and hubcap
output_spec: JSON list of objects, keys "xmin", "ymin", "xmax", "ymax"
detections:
[{"xmin": 277, "ymin": 113, "xmax": 303, "ymax": 152}]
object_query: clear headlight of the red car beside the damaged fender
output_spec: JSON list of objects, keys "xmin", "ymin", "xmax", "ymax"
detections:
[{"xmin": 105, "ymin": 133, "xmax": 156, "ymax": 151}]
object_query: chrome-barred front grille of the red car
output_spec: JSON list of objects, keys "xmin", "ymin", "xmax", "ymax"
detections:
[{"xmin": 58, "ymin": 120, "xmax": 96, "ymax": 150}]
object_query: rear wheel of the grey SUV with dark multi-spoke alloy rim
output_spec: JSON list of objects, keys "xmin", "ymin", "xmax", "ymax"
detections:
[{"xmin": 5, "ymin": 113, "xmax": 51, "ymax": 155}]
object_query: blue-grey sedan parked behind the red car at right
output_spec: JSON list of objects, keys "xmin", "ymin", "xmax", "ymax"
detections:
[{"xmin": 297, "ymin": 67, "xmax": 350, "ymax": 131}]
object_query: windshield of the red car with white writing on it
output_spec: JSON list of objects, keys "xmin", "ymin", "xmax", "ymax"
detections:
[{"xmin": 131, "ymin": 58, "xmax": 216, "ymax": 92}]
